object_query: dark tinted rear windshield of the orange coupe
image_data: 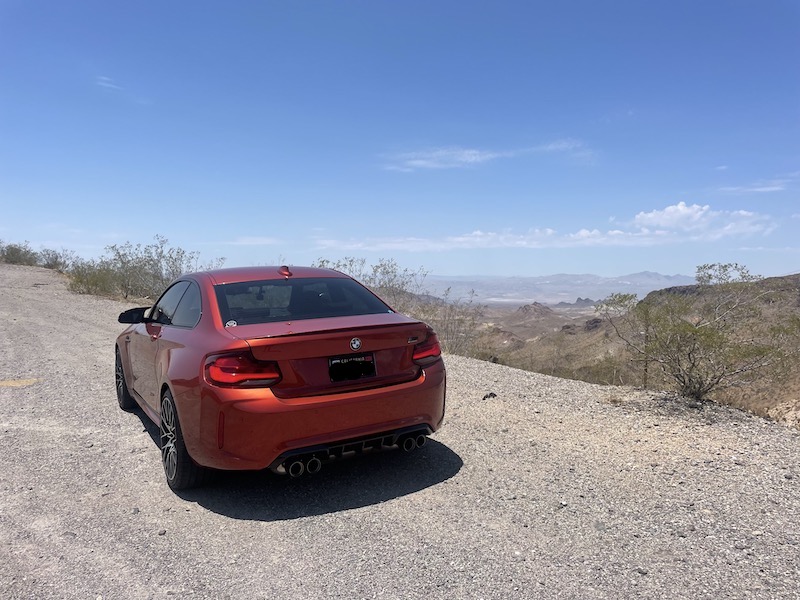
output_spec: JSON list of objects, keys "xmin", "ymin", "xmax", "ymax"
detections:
[{"xmin": 214, "ymin": 278, "xmax": 392, "ymax": 327}]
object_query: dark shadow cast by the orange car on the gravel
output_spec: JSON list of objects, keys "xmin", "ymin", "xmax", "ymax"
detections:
[{"xmin": 134, "ymin": 410, "xmax": 464, "ymax": 521}]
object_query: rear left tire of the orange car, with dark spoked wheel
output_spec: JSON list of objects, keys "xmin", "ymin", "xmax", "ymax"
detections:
[{"xmin": 159, "ymin": 390, "xmax": 207, "ymax": 490}]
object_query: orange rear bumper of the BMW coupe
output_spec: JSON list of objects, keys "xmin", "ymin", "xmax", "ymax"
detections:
[{"xmin": 184, "ymin": 361, "xmax": 446, "ymax": 472}]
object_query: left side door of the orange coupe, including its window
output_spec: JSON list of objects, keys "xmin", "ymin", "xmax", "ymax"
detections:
[{"xmin": 130, "ymin": 281, "xmax": 190, "ymax": 413}]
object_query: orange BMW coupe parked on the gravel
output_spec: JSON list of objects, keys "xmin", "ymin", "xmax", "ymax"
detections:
[{"xmin": 115, "ymin": 266, "xmax": 446, "ymax": 490}]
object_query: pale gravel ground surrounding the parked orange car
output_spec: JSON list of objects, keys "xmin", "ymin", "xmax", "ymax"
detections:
[{"xmin": 0, "ymin": 265, "xmax": 800, "ymax": 599}]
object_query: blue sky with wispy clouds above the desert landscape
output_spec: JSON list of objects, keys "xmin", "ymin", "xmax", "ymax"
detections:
[{"xmin": 0, "ymin": 0, "xmax": 800, "ymax": 276}]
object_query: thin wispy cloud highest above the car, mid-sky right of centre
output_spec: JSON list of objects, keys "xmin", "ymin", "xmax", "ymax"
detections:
[{"xmin": 384, "ymin": 138, "xmax": 592, "ymax": 172}]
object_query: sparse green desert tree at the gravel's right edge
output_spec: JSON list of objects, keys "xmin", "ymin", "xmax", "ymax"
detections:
[{"xmin": 597, "ymin": 263, "xmax": 800, "ymax": 400}]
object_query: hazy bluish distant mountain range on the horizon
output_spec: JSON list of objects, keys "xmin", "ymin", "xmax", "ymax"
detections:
[{"xmin": 425, "ymin": 271, "xmax": 695, "ymax": 306}]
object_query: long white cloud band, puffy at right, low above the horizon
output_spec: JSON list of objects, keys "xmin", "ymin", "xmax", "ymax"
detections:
[{"xmin": 316, "ymin": 202, "xmax": 776, "ymax": 251}]
